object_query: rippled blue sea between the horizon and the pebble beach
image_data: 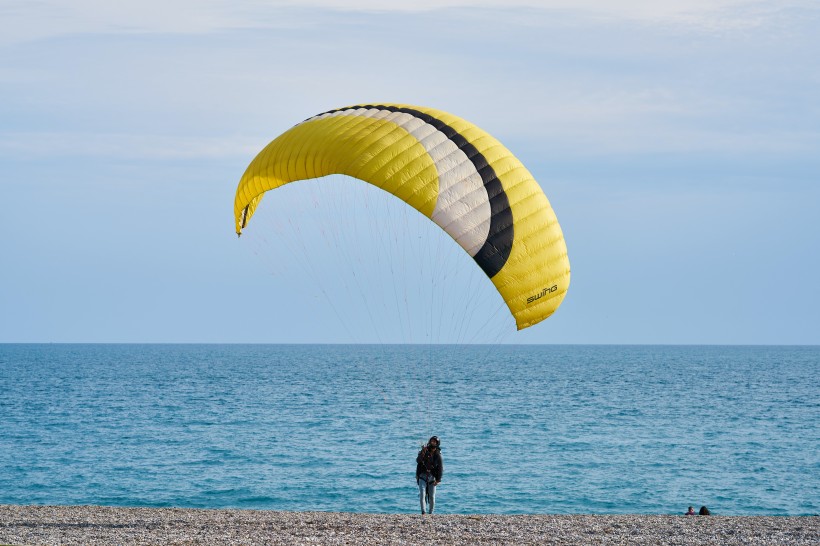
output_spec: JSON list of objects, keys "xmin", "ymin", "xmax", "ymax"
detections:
[{"xmin": 0, "ymin": 345, "xmax": 820, "ymax": 515}]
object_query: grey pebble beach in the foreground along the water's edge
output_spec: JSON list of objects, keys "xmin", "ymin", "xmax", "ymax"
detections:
[{"xmin": 0, "ymin": 505, "xmax": 820, "ymax": 545}]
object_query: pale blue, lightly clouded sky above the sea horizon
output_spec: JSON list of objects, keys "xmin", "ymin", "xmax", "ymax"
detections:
[{"xmin": 0, "ymin": 0, "xmax": 820, "ymax": 344}]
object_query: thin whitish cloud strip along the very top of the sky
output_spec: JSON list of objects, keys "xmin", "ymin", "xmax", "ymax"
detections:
[{"xmin": 0, "ymin": 0, "xmax": 816, "ymax": 43}]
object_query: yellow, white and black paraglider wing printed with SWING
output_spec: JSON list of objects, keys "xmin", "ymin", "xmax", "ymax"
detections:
[{"xmin": 234, "ymin": 104, "xmax": 570, "ymax": 330}]
